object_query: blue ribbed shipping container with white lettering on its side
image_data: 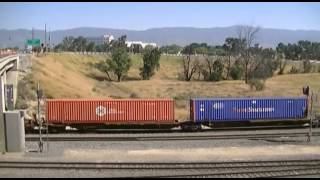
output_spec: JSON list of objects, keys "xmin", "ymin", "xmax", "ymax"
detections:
[{"xmin": 190, "ymin": 97, "xmax": 307, "ymax": 123}]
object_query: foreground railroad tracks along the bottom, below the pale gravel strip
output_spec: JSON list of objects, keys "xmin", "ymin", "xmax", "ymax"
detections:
[{"xmin": 0, "ymin": 159, "xmax": 320, "ymax": 178}]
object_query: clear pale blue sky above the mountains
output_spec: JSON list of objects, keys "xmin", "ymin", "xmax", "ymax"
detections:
[{"xmin": 0, "ymin": 2, "xmax": 320, "ymax": 30}]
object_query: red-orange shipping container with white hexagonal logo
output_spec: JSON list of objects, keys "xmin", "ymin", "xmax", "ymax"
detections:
[{"xmin": 46, "ymin": 99, "xmax": 175, "ymax": 124}]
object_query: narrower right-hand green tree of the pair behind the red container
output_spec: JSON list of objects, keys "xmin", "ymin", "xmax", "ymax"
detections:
[{"xmin": 140, "ymin": 47, "xmax": 161, "ymax": 80}]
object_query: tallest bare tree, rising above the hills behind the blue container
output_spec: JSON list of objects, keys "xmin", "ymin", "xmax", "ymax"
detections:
[{"xmin": 238, "ymin": 25, "xmax": 260, "ymax": 83}]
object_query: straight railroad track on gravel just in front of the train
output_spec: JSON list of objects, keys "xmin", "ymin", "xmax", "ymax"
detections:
[{"xmin": 25, "ymin": 132, "xmax": 320, "ymax": 141}]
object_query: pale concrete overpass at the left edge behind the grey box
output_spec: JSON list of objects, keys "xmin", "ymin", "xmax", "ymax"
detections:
[{"xmin": 0, "ymin": 53, "xmax": 19, "ymax": 152}]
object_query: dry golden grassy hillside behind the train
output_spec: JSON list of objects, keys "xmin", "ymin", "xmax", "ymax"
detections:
[{"xmin": 25, "ymin": 53, "xmax": 320, "ymax": 119}]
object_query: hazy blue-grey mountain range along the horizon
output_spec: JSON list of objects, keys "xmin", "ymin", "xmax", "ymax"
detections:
[{"xmin": 0, "ymin": 26, "xmax": 320, "ymax": 48}]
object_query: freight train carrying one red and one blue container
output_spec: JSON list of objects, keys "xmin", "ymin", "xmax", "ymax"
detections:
[{"xmin": 36, "ymin": 91, "xmax": 308, "ymax": 131}]
